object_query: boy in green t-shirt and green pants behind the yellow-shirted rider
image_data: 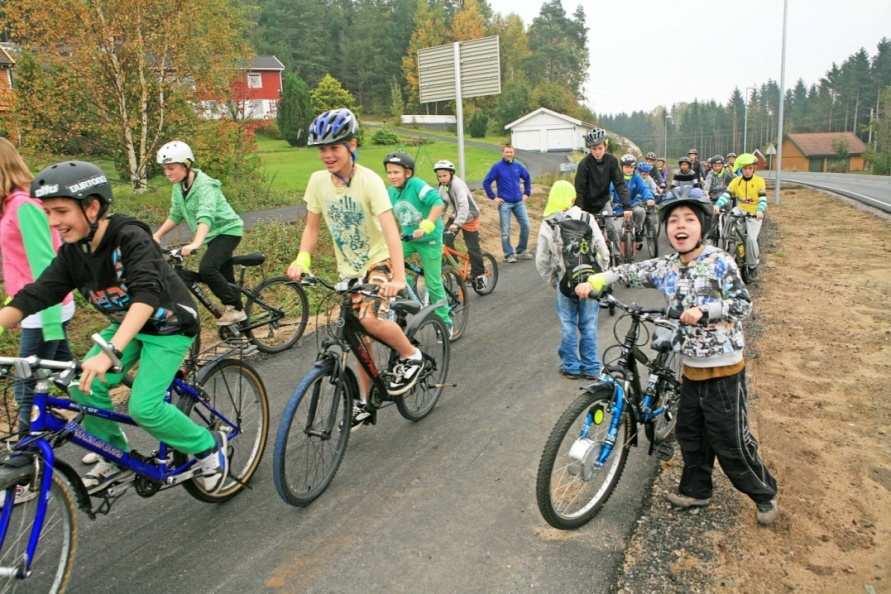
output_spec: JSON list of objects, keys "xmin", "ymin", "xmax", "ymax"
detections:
[{"xmin": 384, "ymin": 153, "xmax": 452, "ymax": 331}]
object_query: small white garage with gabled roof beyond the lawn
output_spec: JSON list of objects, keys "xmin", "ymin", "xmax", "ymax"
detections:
[{"xmin": 504, "ymin": 107, "xmax": 594, "ymax": 153}]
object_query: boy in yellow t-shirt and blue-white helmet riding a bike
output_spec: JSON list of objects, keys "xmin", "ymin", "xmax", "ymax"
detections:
[{"xmin": 288, "ymin": 109, "xmax": 424, "ymax": 410}]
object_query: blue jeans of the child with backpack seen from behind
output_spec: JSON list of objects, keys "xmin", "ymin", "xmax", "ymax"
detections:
[{"xmin": 557, "ymin": 290, "xmax": 601, "ymax": 375}]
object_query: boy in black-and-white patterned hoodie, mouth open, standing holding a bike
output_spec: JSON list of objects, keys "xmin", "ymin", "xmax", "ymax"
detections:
[{"xmin": 576, "ymin": 191, "xmax": 779, "ymax": 525}]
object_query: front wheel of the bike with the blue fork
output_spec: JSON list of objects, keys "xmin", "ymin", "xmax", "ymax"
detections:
[{"xmin": 535, "ymin": 386, "xmax": 634, "ymax": 530}]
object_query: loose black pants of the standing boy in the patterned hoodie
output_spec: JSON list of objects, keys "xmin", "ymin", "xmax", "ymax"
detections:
[{"xmin": 676, "ymin": 370, "xmax": 777, "ymax": 503}]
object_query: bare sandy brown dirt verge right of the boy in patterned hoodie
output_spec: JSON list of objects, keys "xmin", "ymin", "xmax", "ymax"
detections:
[{"xmin": 620, "ymin": 189, "xmax": 891, "ymax": 593}]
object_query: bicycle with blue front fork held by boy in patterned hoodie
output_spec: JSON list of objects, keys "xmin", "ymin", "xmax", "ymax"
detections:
[{"xmin": 536, "ymin": 295, "xmax": 681, "ymax": 530}]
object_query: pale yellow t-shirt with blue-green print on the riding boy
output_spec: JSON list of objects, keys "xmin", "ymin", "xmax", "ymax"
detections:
[{"xmin": 303, "ymin": 164, "xmax": 393, "ymax": 278}]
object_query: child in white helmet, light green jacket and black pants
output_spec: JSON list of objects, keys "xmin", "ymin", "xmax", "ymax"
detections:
[{"xmin": 154, "ymin": 140, "xmax": 247, "ymax": 326}]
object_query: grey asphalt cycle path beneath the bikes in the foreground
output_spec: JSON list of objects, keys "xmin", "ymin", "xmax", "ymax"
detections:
[{"xmin": 65, "ymin": 262, "xmax": 662, "ymax": 594}]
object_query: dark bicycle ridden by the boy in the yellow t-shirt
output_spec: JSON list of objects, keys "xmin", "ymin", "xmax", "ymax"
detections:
[{"xmin": 272, "ymin": 277, "xmax": 449, "ymax": 507}]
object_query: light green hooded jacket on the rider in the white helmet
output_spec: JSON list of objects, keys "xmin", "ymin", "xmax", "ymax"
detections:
[{"xmin": 168, "ymin": 169, "xmax": 244, "ymax": 245}]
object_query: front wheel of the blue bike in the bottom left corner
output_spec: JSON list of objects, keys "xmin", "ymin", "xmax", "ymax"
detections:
[{"xmin": 0, "ymin": 472, "xmax": 77, "ymax": 593}]
